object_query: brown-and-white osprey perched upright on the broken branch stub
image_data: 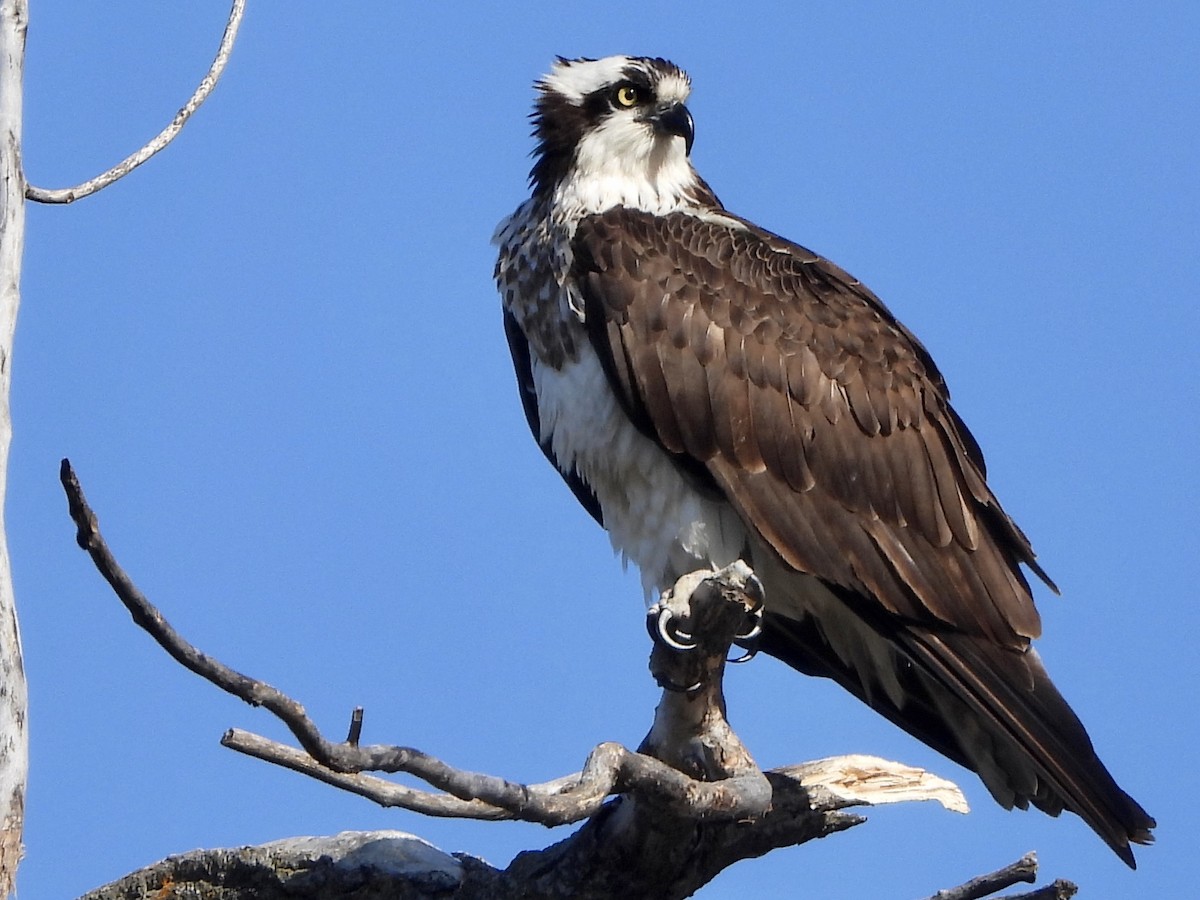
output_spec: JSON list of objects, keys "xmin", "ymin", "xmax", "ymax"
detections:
[{"xmin": 494, "ymin": 56, "xmax": 1154, "ymax": 866}]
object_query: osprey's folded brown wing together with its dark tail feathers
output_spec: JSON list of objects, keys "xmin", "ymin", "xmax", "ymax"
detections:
[{"xmin": 572, "ymin": 208, "xmax": 1153, "ymax": 865}]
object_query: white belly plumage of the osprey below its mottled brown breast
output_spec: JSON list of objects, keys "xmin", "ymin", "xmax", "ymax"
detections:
[{"xmin": 533, "ymin": 347, "xmax": 746, "ymax": 600}]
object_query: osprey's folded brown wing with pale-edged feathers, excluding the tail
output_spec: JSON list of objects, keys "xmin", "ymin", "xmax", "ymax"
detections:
[{"xmin": 575, "ymin": 209, "xmax": 1040, "ymax": 647}]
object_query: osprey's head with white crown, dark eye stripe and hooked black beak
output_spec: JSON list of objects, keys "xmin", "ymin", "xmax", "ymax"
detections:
[{"xmin": 529, "ymin": 56, "xmax": 695, "ymax": 200}]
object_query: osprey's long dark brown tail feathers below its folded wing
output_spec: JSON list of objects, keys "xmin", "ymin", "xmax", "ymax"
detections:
[{"xmin": 762, "ymin": 602, "xmax": 1154, "ymax": 868}]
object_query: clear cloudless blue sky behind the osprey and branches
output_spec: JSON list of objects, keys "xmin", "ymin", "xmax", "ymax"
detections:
[{"xmin": 7, "ymin": 1, "xmax": 1200, "ymax": 900}]
